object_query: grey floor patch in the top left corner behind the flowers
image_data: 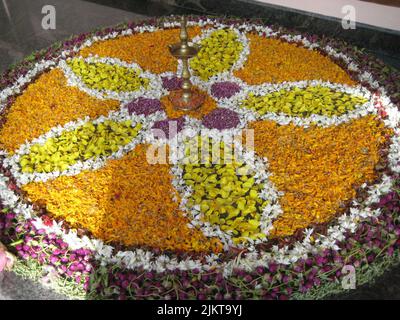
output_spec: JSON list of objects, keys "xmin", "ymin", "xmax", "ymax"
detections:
[{"xmin": 0, "ymin": 0, "xmax": 150, "ymax": 71}]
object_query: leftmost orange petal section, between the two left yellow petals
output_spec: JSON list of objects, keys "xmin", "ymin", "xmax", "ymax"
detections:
[{"xmin": 0, "ymin": 69, "xmax": 119, "ymax": 153}]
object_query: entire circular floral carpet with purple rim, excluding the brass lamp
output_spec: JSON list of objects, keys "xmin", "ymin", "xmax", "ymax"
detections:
[{"xmin": 0, "ymin": 17, "xmax": 400, "ymax": 299}]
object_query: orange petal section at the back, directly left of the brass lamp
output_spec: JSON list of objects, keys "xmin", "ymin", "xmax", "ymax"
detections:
[{"xmin": 80, "ymin": 27, "xmax": 201, "ymax": 74}]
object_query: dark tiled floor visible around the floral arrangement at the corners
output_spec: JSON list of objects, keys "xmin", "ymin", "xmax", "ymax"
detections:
[{"xmin": 0, "ymin": 0, "xmax": 400, "ymax": 300}]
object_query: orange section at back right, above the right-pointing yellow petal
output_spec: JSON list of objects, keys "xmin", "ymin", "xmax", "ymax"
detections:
[{"xmin": 234, "ymin": 34, "xmax": 355, "ymax": 85}]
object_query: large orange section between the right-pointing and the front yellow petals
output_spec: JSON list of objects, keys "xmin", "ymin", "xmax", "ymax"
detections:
[{"xmin": 251, "ymin": 116, "xmax": 390, "ymax": 237}]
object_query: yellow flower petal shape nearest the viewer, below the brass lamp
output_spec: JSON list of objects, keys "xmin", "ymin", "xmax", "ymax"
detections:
[{"xmin": 182, "ymin": 137, "xmax": 267, "ymax": 243}]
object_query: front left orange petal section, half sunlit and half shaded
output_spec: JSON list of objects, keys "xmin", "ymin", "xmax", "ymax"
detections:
[{"xmin": 23, "ymin": 145, "xmax": 222, "ymax": 252}]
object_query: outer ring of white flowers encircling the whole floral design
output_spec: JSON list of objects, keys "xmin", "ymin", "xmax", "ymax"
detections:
[{"xmin": 0, "ymin": 19, "xmax": 400, "ymax": 276}]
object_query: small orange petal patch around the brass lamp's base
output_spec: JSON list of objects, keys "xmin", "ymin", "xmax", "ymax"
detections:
[{"xmin": 161, "ymin": 87, "xmax": 217, "ymax": 119}]
